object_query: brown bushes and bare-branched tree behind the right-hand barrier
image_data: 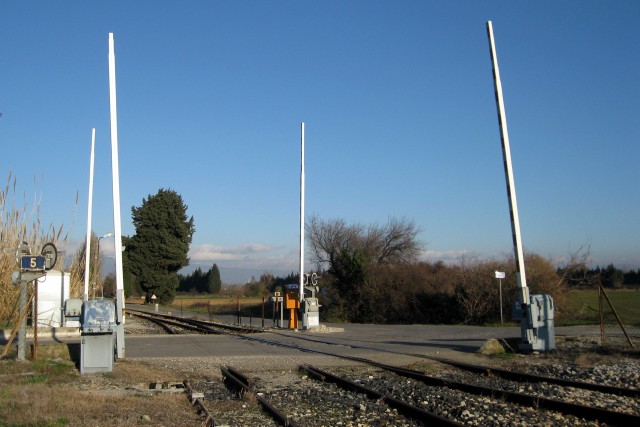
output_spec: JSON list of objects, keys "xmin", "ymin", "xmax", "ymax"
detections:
[{"xmin": 306, "ymin": 217, "xmax": 572, "ymax": 325}]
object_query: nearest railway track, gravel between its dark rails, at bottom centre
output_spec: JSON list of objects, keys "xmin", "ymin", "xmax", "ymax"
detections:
[{"xmin": 189, "ymin": 365, "xmax": 462, "ymax": 427}]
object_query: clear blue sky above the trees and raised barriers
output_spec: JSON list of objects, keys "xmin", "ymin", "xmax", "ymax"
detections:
[{"xmin": 0, "ymin": 0, "xmax": 640, "ymax": 282}]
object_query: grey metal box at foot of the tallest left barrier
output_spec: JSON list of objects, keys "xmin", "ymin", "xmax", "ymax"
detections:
[{"xmin": 80, "ymin": 300, "xmax": 116, "ymax": 374}]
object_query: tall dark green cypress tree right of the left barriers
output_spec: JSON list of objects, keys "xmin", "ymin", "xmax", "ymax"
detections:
[{"xmin": 123, "ymin": 189, "xmax": 195, "ymax": 303}]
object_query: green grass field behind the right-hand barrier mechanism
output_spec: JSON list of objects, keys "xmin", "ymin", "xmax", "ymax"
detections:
[{"xmin": 558, "ymin": 289, "xmax": 640, "ymax": 326}]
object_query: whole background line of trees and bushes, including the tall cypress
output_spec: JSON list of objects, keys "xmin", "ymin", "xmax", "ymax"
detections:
[{"xmin": 101, "ymin": 190, "xmax": 638, "ymax": 324}]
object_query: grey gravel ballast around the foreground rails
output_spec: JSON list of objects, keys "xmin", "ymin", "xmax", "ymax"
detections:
[{"xmin": 127, "ymin": 316, "xmax": 640, "ymax": 426}]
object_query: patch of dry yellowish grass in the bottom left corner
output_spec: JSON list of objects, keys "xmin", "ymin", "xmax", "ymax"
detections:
[{"xmin": 0, "ymin": 352, "xmax": 202, "ymax": 426}]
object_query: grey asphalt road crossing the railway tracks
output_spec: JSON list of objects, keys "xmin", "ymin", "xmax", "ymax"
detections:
[{"xmin": 126, "ymin": 307, "xmax": 599, "ymax": 363}]
